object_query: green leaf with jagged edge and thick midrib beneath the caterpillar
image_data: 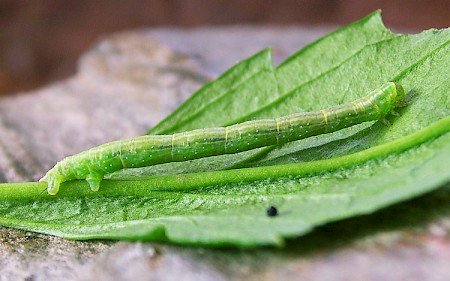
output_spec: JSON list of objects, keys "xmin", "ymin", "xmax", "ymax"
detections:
[{"xmin": 0, "ymin": 13, "xmax": 450, "ymax": 247}]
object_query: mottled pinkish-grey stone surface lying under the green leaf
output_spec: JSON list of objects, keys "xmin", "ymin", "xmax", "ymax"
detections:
[{"xmin": 0, "ymin": 27, "xmax": 450, "ymax": 281}]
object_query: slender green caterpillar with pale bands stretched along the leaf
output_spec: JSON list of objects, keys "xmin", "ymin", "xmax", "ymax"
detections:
[{"xmin": 40, "ymin": 82, "xmax": 405, "ymax": 195}]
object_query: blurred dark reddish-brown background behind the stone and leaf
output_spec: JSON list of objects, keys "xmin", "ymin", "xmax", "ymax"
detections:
[{"xmin": 0, "ymin": 0, "xmax": 450, "ymax": 95}]
